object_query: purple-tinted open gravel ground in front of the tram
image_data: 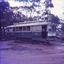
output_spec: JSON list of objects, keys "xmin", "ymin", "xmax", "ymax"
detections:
[{"xmin": 0, "ymin": 41, "xmax": 64, "ymax": 64}]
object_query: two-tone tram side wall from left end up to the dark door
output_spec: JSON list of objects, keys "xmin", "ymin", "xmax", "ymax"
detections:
[{"xmin": 6, "ymin": 25, "xmax": 46, "ymax": 40}]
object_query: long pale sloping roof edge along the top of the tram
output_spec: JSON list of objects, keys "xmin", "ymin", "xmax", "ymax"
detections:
[{"xmin": 7, "ymin": 22, "xmax": 50, "ymax": 28}]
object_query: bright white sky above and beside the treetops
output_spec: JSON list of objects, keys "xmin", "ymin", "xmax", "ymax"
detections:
[{"xmin": 6, "ymin": 0, "xmax": 64, "ymax": 19}]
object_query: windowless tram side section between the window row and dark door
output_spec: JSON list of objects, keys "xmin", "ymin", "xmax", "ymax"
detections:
[{"xmin": 31, "ymin": 26, "xmax": 41, "ymax": 40}]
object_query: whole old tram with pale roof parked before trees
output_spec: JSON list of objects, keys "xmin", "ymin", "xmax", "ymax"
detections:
[{"xmin": 5, "ymin": 21, "xmax": 56, "ymax": 41}]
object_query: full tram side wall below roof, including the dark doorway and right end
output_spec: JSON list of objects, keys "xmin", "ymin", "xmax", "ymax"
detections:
[{"xmin": 6, "ymin": 25, "xmax": 55, "ymax": 40}]
